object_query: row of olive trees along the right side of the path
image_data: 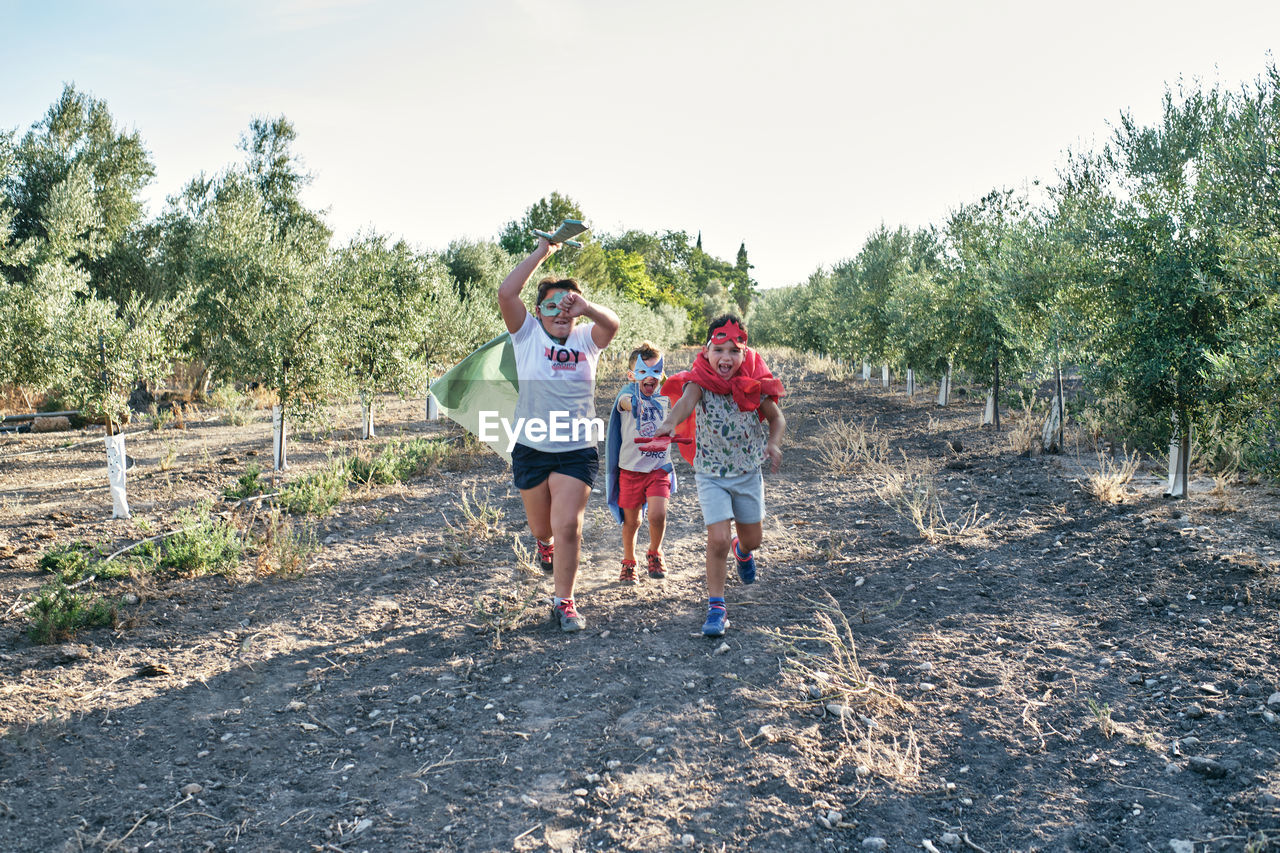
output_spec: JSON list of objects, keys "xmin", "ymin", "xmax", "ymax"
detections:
[{"xmin": 751, "ymin": 65, "xmax": 1280, "ymax": 476}]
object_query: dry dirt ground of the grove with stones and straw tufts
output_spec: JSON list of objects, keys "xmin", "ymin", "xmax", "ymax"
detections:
[{"xmin": 0, "ymin": 359, "xmax": 1280, "ymax": 853}]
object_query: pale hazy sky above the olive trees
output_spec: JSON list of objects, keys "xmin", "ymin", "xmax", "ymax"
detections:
[{"xmin": 0, "ymin": 0, "xmax": 1280, "ymax": 287}]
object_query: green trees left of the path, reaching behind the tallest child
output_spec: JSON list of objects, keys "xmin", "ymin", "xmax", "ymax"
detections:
[{"xmin": 0, "ymin": 86, "xmax": 755, "ymax": 421}]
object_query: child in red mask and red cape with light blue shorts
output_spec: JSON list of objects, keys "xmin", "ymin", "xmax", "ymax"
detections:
[{"xmin": 655, "ymin": 314, "xmax": 787, "ymax": 637}]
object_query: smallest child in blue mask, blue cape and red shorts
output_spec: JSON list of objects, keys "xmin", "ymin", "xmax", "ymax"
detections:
[{"xmin": 605, "ymin": 341, "xmax": 676, "ymax": 584}]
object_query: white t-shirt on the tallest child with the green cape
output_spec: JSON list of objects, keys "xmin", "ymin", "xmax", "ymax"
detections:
[{"xmin": 511, "ymin": 308, "xmax": 604, "ymax": 453}]
